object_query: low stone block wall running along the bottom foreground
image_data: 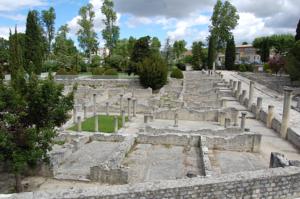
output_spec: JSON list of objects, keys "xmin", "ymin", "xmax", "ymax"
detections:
[{"xmin": 7, "ymin": 167, "xmax": 300, "ymax": 199}]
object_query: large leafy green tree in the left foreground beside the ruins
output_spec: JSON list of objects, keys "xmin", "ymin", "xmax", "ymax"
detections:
[{"xmin": 0, "ymin": 73, "xmax": 73, "ymax": 192}]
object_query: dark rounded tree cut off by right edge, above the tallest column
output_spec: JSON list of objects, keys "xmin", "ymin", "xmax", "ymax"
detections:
[{"xmin": 286, "ymin": 41, "xmax": 300, "ymax": 81}]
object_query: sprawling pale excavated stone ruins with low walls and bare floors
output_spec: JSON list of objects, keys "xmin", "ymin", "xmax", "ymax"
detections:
[{"xmin": 2, "ymin": 71, "xmax": 300, "ymax": 198}]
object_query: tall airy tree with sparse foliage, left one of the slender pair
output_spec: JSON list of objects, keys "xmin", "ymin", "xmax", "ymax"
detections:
[{"xmin": 77, "ymin": 3, "xmax": 98, "ymax": 63}]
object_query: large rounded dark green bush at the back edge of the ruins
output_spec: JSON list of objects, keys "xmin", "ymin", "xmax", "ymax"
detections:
[{"xmin": 139, "ymin": 55, "xmax": 168, "ymax": 90}]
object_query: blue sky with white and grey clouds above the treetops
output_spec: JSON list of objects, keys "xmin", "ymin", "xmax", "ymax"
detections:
[{"xmin": 0, "ymin": 0, "xmax": 300, "ymax": 46}]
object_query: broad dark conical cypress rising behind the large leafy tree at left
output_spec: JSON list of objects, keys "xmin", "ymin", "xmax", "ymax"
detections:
[{"xmin": 24, "ymin": 10, "xmax": 44, "ymax": 74}]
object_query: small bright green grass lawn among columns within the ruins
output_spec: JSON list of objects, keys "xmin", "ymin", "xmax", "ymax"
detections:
[{"xmin": 69, "ymin": 115, "xmax": 128, "ymax": 133}]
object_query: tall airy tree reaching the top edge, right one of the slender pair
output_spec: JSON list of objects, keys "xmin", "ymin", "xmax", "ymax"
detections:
[{"xmin": 101, "ymin": 0, "xmax": 120, "ymax": 54}]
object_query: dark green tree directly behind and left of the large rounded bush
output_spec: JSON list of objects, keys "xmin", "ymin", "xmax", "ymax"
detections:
[{"xmin": 128, "ymin": 36, "xmax": 152, "ymax": 75}]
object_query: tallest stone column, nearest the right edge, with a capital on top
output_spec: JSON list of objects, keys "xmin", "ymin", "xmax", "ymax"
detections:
[{"xmin": 280, "ymin": 87, "xmax": 293, "ymax": 139}]
